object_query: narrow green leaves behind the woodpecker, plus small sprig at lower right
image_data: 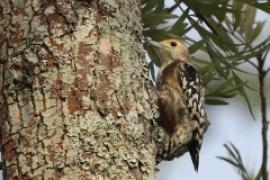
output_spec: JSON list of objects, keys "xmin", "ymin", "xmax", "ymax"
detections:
[{"xmin": 142, "ymin": 0, "xmax": 270, "ymax": 179}]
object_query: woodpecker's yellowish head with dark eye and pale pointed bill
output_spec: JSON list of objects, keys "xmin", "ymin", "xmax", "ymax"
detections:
[{"xmin": 151, "ymin": 39, "xmax": 191, "ymax": 64}]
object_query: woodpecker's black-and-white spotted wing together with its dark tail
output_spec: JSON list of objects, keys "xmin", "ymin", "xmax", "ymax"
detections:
[{"xmin": 178, "ymin": 63, "xmax": 208, "ymax": 170}]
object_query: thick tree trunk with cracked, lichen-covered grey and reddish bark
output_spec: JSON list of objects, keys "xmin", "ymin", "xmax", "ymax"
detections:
[{"xmin": 0, "ymin": 0, "xmax": 156, "ymax": 180}]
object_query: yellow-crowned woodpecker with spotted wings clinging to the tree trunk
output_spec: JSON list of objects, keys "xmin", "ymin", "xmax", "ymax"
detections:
[{"xmin": 150, "ymin": 39, "xmax": 208, "ymax": 171}]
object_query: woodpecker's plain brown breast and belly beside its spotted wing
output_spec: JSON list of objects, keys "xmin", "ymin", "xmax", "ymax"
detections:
[{"xmin": 156, "ymin": 61, "xmax": 187, "ymax": 135}]
